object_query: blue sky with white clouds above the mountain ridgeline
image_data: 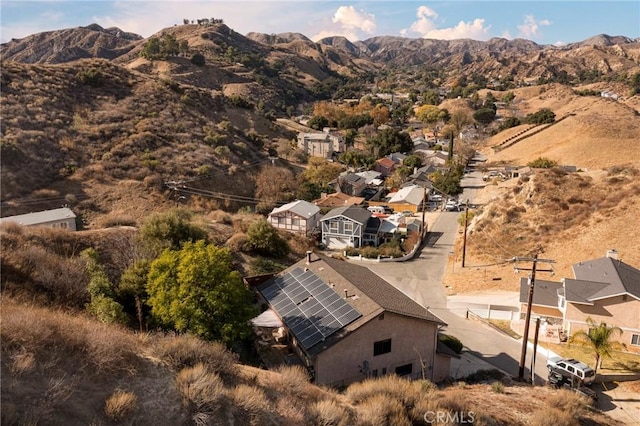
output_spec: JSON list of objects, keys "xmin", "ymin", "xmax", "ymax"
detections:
[{"xmin": 0, "ymin": 0, "xmax": 640, "ymax": 44}]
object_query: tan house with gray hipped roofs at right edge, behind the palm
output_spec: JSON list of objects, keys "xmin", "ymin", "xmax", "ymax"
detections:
[{"xmin": 520, "ymin": 250, "xmax": 640, "ymax": 352}]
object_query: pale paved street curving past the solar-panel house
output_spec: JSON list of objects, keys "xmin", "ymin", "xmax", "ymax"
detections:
[{"xmin": 367, "ymin": 167, "xmax": 546, "ymax": 381}]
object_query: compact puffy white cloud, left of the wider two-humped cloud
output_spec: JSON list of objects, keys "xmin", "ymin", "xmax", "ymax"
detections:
[{"xmin": 310, "ymin": 6, "xmax": 377, "ymax": 41}]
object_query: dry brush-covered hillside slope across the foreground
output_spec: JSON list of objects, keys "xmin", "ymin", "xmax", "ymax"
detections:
[{"xmin": 0, "ymin": 297, "xmax": 617, "ymax": 425}]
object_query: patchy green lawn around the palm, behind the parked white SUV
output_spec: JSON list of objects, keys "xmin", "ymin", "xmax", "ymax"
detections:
[{"xmin": 540, "ymin": 342, "xmax": 640, "ymax": 373}]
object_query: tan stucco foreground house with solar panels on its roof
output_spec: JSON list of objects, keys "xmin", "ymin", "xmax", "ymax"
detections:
[{"xmin": 256, "ymin": 252, "xmax": 452, "ymax": 387}]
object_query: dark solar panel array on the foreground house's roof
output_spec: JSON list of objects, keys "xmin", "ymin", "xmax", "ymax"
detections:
[{"xmin": 258, "ymin": 268, "xmax": 362, "ymax": 349}]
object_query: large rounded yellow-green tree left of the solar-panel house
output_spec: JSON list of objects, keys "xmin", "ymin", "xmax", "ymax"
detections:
[{"xmin": 147, "ymin": 240, "xmax": 256, "ymax": 345}]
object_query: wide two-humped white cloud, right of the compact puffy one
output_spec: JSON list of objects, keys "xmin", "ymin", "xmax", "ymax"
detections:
[{"xmin": 400, "ymin": 6, "xmax": 491, "ymax": 40}]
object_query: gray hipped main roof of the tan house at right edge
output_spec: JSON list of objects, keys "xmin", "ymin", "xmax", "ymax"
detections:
[{"xmin": 573, "ymin": 257, "xmax": 640, "ymax": 301}]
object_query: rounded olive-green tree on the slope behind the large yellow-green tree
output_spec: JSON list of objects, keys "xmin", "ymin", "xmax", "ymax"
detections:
[{"xmin": 140, "ymin": 209, "xmax": 207, "ymax": 253}]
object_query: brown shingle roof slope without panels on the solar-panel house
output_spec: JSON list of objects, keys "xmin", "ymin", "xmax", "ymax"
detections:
[{"xmin": 320, "ymin": 256, "xmax": 444, "ymax": 324}]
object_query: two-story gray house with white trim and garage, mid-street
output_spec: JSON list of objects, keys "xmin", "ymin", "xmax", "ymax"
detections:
[{"xmin": 320, "ymin": 206, "xmax": 371, "ymax": 250}]
